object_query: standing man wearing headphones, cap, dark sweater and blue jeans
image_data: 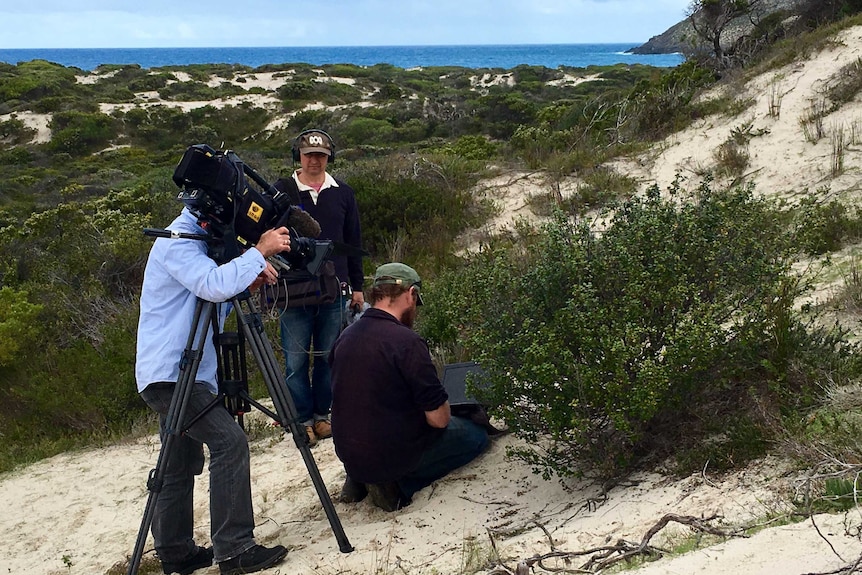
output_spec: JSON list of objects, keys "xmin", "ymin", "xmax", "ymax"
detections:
[{"xmin": 274, "ymin": 129, "xmax": 365, "ymax": 445}]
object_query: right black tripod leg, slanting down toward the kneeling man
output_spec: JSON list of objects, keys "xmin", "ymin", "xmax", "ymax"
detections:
[{"xmin": 233, "ymin": 291, "xmax": 353, "ymax": 553}]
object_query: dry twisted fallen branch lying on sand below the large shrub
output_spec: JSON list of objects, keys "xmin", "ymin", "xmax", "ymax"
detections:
[{"xmin": 489, "ymin": 513, "xmax": 745, "ymax": 575}]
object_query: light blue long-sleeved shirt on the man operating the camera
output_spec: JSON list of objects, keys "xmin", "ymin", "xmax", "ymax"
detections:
[{"xmin": 135, "ymin": 208, "xmax": 266, "ymax": 393}]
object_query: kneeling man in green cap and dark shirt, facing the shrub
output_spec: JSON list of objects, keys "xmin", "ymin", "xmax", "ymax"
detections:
[{"xmin": 329, "ymin": 263, "xmax": 489, "ymax": 511}]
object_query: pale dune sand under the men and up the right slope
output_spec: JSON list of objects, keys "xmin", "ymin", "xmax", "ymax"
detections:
[{"xmin": 0, "ymin": 22, "xmax": 862, "ymax": 575}]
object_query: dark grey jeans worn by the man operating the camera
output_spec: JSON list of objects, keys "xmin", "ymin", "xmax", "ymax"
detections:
[{"xmin": 141, "ymin": 383, "xmax": 255, "ymax": 563}]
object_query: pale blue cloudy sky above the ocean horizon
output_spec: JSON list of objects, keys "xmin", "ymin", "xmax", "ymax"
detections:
[{"xmin": 0, "ymin": 0, "xmax": 690, "ymax": 48}]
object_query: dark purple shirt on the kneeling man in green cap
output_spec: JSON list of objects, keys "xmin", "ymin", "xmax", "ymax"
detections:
[{"xmin": 329, "ymin": 308, "xmax": 448, "ymax": 483}]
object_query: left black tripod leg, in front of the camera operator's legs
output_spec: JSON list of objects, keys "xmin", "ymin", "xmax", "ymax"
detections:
[{"xmin": 126, "ymin": 299, "xmax": 215, "ymax": 575}]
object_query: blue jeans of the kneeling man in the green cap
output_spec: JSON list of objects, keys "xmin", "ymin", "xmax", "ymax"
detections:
[{"xmin": 398, "ymin": 417, "xmax": 491, "ymax": 499}]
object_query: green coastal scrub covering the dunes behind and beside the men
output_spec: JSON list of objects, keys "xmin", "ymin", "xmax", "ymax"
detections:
[{"xmin": 0, "ymin": 5, "xmax": 862, "ymax": 532}]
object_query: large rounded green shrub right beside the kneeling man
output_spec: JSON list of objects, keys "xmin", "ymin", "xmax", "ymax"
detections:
[{"xmin": 422, "ymin": 182, "xmax": 855, "ymax": 477}]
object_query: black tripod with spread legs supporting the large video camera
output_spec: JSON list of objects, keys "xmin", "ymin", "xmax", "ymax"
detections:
[{"xmin": 127, "ymin": 290, "xmax": 353, "ymax": 575}]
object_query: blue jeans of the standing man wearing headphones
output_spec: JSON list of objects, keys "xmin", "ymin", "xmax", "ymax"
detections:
[{"xmin": 280, "ymin": 297, "xmax": 344, "ymax": 425}]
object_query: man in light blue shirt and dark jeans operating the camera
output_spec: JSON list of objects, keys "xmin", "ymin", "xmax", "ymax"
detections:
[{"xmin": 135, "ymin": 207, "xmax": 290, "ymax": 575}]
